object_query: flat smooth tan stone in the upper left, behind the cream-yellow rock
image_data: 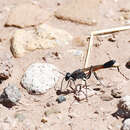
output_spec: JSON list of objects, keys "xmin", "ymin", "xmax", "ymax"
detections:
[{"xmin": 5, "ymin": 3, "xmax": 51, "ymax": 28}]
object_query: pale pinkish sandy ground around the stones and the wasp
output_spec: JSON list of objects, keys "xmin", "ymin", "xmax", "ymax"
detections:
[{"xmin": 0, "ymin": 0, "xmax": 130, "ymax": 130}]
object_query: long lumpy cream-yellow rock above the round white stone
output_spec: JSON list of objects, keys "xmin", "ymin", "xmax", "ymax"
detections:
[{"xmin": 11, "ymin": 24, "xmax": 72, "ymax": 57}]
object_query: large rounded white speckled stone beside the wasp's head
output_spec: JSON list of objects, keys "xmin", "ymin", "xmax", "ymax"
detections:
[{"xmin": 21, "ymin": 63, "xmax": 59, "ymax": 94}]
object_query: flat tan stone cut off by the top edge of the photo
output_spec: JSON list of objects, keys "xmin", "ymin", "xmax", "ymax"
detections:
[{"xmin": 55, "ymin": 0, "xmax": 100, "ymax": 25}]
